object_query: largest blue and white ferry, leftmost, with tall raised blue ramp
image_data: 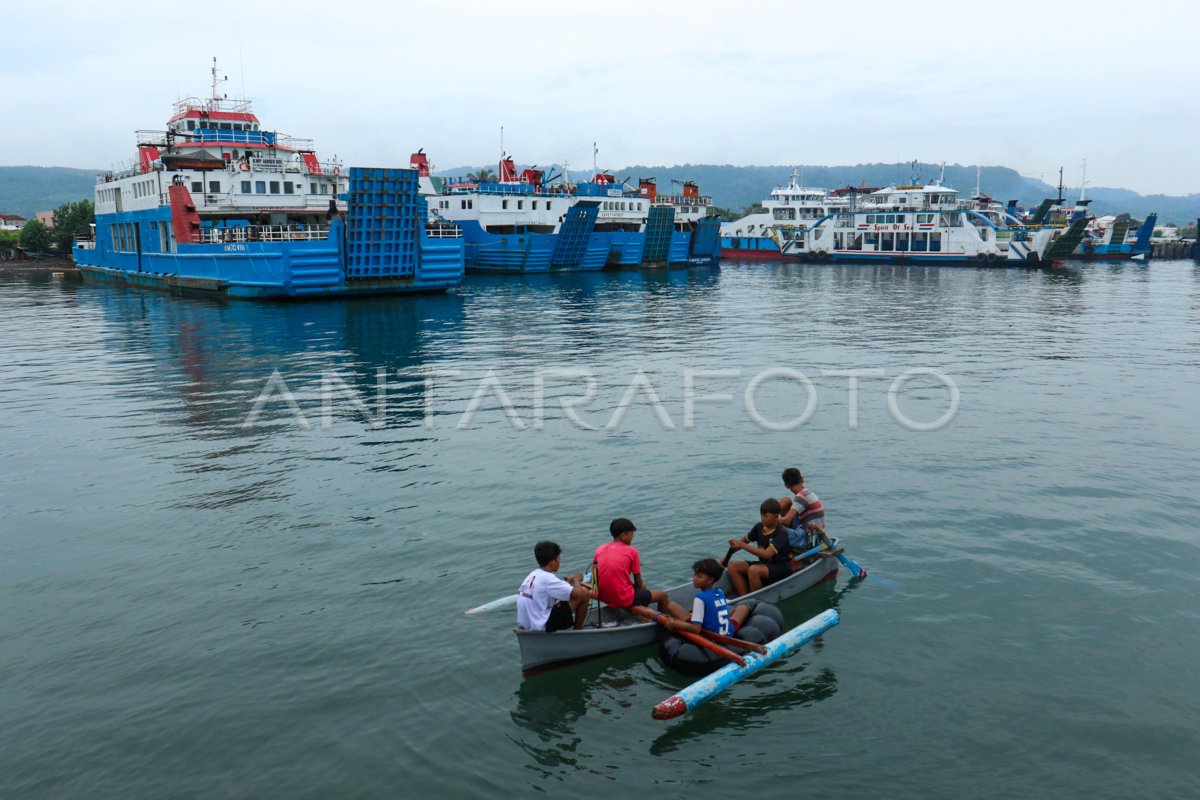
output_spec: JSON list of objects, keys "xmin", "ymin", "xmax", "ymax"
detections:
[{"xmin": 73, "ymin": 59, "xmax": 464, "ymax": 299}]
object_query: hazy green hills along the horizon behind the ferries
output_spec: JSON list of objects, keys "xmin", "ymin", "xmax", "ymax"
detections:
[{"xmin": 0, "ymin": 164, "xmax": 1200, "ymax": 224}]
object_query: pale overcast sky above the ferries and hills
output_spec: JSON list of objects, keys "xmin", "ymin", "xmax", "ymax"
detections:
[{"xmin": 0, "ymin": 0, "xmax": 1200, "ymax": 194}]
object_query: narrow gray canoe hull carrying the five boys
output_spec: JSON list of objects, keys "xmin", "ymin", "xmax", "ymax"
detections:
[{"xmin": 514, "ymin": 540, "xmax": 838, "ymax": 672}]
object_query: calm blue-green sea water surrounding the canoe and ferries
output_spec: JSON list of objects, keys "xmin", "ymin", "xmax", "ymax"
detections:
[{"xmin": 0, "ymin": 261, "xmax": 1200, "ymax": 798}]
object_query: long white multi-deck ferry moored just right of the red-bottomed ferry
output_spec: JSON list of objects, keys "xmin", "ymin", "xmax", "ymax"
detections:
[{"xmin": 772, "ymin": 182, "xmax": 1086, "ymax": 266}]
